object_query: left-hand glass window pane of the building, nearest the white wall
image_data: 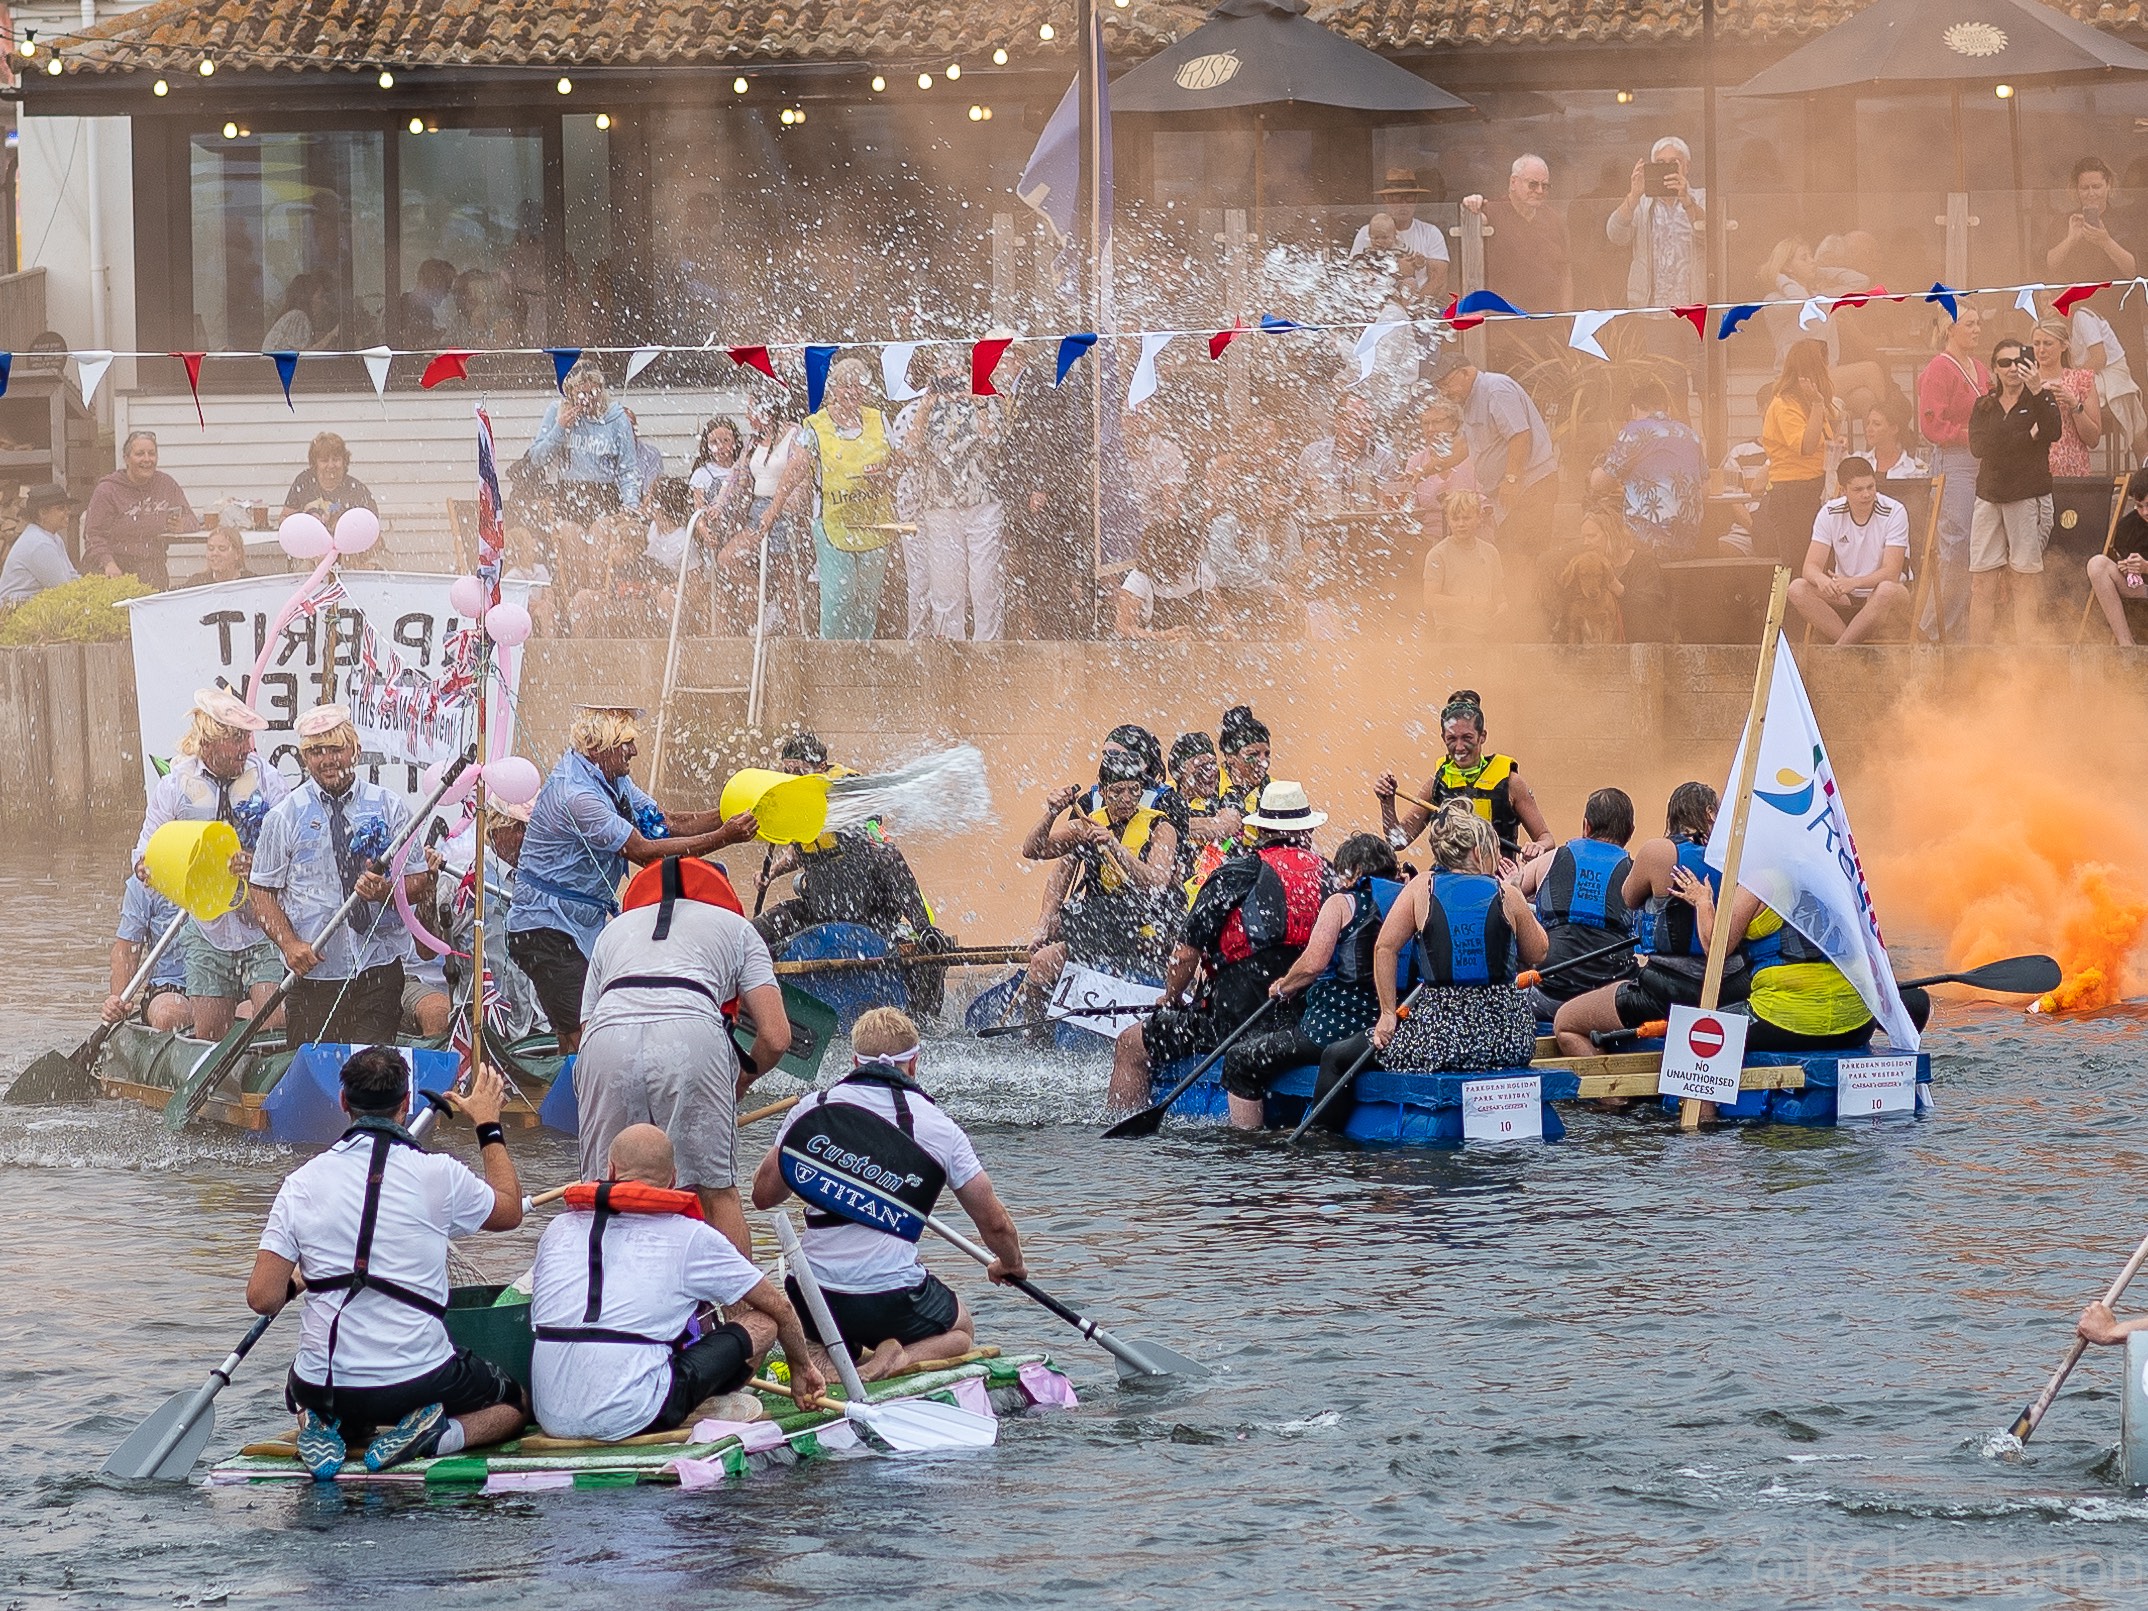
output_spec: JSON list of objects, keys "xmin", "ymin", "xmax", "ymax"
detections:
[{"xmin": 189, "ymin": 127, "xmax": 387, "ymax": 352}]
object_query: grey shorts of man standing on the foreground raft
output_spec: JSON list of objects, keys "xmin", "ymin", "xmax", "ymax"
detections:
[{"xmin": 574, "ymin": 1014, "xmax": 739, "ymax": 1190}]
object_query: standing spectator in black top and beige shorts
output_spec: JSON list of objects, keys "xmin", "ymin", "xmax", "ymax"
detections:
[{"xmin": 1970, "ymin": 335, "xmax": 2062, "ymax": 644}]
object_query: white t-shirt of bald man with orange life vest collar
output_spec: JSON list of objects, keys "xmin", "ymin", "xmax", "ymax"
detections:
[{"xmin": 531, "ymin": 1209, "xmax": 760, "ymax": 1439}]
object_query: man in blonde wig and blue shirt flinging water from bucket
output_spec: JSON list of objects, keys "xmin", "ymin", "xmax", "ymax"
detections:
[{"xmin": 507, "ymin": 705, "xmax": 758, "ymax": 1053}]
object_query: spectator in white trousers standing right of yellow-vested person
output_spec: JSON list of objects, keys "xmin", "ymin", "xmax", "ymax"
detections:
[{"xmin": 894, "ymin": 343, "xmax": 1012, "ymax": 642}]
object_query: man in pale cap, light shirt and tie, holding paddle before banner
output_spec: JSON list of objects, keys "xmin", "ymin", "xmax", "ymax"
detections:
[{"xmin": 253, "ymin": 705, "xmax": 432, "ymax": 1046}]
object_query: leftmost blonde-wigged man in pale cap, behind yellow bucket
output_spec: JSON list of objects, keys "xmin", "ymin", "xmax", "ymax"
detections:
[{"xmin": 133, "ymin": 687, "xmax": 288, "ymax": 1040}]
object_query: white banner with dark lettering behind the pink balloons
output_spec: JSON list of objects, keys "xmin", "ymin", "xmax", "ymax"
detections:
[{"xmin": 122, "ymin": 571, "xmax": 530, "ymax": 820}]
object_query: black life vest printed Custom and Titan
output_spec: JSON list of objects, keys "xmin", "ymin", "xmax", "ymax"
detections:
[{"xmin": 778, "ymin": 1063, "xmax": 947, "ymax": 1242}]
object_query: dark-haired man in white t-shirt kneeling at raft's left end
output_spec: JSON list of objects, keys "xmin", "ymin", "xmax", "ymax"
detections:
[{"xmin": 247, "ymin": 1046, "xmax": 526, "ymax": 1482}]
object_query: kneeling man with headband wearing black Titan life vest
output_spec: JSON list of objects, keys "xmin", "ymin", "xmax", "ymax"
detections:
[{"xmin": 754, "ymin": 1007, "xmax": 1029, "ymax": 1381}]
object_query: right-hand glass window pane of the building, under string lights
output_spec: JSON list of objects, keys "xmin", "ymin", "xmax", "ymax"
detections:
[{"xmin": 395, "ymin": 129, "xmax": 548, "ymax": 348}]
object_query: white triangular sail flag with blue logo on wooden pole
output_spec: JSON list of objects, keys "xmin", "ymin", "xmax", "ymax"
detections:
[{"xmin": 1708, "ymin": 642, "xmax": 1916, "ymax": 1053}]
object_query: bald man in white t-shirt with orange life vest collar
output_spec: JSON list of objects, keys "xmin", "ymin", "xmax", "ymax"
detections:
[{"xmin": 531, "ymin": 1123, "xmax": 827, "ymax": 1443}]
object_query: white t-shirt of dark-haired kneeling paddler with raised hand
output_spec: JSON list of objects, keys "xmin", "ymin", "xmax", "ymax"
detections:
[{"xmin": 260, "ymin": 1132, "xmax": 494, "ymax": 1388}]
